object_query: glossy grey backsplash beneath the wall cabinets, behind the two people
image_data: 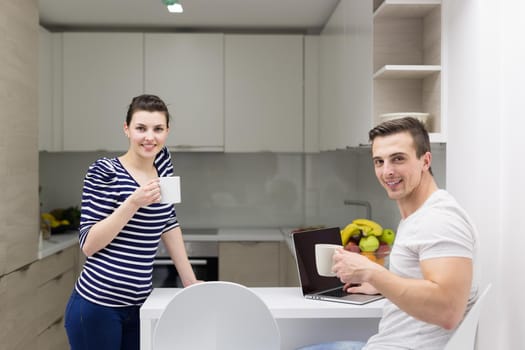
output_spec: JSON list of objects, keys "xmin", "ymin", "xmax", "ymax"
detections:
[{"xmin": 40, "ymin": 148, "xmax": 445, "ymax": 228}]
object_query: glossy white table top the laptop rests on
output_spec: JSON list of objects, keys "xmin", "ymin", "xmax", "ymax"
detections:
[{"xmin": 140, "ymin": 287, "xmax": 385, "ymax": 321}]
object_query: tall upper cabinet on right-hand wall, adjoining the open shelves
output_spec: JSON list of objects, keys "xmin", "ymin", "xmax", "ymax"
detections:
[{"xmin": 319, "ymin": 0, "xmax": 373, "ymax": 151}]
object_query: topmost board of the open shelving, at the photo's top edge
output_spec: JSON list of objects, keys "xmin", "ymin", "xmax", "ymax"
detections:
[{"xmin": 374, "ymin": 0, "xmax": 441, "ymax": 19}]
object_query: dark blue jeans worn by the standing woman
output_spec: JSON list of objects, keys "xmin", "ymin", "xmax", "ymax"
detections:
[{"xmin": 65, "ymin": 290, "xmax": 140, "ymax": 350}]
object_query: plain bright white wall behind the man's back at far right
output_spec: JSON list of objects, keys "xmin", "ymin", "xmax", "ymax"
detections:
[{"xmin": 443, "ymin": 0, "xmax": 525, "ymax": 350}]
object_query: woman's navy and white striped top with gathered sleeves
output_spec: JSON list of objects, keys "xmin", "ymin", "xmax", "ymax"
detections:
[{"xmin": 75, "ymin": 148, "xmax": 179, "ymax": 307}]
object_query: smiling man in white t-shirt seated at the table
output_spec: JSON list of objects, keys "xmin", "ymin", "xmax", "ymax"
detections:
[{"xmin": 298, "ymin": 118, "xmax": 478, "ymax": 350}]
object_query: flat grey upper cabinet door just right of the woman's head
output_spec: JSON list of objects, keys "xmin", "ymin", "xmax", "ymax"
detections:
[{"xmin": 144, "ymin": 33, "xmax": 224, "ymax": 151}]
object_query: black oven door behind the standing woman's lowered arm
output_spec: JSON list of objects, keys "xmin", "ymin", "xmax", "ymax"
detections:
[{"xmin": 152, "ymin": 257, "xmax": 219, "ymax": 288}]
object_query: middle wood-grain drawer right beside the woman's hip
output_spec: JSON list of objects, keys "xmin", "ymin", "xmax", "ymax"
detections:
[{"xmin": 37, "ymin": 269, "xmax": 75, "ymax": 334}]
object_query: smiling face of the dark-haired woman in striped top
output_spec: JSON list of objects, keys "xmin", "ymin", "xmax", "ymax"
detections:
[{"xmin": 124, "ymin": 110, "xmax": 169, "ymax": 158}]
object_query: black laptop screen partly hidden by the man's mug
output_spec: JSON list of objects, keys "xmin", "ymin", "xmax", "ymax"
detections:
[{"xmin": 292, "ymin": 227, "xmax": 342, "ymax": 295}]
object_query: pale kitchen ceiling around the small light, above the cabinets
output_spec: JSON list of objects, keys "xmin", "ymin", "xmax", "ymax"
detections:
[{"xmin": 39, "ymin": 0, "xmax": 339, "ymax": 34}]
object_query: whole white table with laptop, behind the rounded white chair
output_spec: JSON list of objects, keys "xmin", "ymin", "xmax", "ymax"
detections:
[{"xmin": 140, "ymin": 287, "xmax": 384, "ymax": 350}]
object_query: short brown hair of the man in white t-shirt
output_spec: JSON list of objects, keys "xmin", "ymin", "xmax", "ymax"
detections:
[{"xmin": 368, "ymin": 117, "xmax": 432, "ymax": 174}]
